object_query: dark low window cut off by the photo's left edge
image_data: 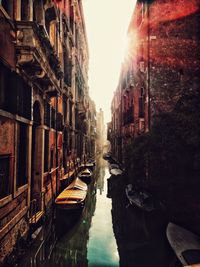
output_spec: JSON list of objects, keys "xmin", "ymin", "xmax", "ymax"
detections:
[{"xmin": 0, "ymin": 155, "xmax": 11, "ymax": 198}]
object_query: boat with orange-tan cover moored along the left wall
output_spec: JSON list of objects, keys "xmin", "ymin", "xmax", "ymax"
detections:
[{"xmin": 55, "ymin": 178, "xmax": 87, "ymax": 210}]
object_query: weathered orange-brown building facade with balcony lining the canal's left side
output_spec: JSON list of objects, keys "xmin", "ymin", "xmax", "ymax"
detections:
[{"xmin": 0, "ymin": 0, "xmax": 95, "ymax": 264}]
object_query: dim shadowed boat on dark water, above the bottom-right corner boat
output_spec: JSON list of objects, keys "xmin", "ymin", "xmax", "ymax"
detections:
[{"xmin": 126, "ymin": 184, "xmax": 164, "ymax": 212}]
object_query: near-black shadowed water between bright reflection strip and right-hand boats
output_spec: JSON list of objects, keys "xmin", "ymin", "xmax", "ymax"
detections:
[{"xmin": 111, "ymin": 177, "xmax": 180, "ymax": 267}]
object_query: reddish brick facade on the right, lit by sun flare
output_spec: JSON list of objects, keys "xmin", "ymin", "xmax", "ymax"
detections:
[{"xmin": 109, "ymin": 0, "xmax": 200, "ymax": 161}]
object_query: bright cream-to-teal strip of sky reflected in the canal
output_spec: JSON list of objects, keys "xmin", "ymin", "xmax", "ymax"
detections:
[{"xmin": 88, "ymin": 162, "xmax": 119, "ymax": 267}]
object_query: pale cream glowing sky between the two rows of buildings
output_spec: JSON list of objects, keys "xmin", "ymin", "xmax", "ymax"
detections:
[{"xmin": 82, "ymin": 0, "xmax": 135, "ymax": 122}]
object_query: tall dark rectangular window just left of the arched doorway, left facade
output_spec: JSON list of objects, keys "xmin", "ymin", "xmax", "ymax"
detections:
[{"xmin": 16, "ymin": 123, "xmax": 28, "ymax": 188}]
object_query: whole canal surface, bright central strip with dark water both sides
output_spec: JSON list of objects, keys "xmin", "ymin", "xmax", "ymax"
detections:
[{"xmin": 15, "ymin": 158, "xmax": 180, "ymax": 267}]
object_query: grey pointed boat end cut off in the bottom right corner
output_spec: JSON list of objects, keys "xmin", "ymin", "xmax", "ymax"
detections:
[{"xmin": 166, "ymin": 223, "xmax": 200, "ymax": 266}]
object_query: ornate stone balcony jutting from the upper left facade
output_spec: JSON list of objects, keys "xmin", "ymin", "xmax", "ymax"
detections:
[{"xmin": 16, "ymin": 21, "xmax": 63, "ymax": 92}]
